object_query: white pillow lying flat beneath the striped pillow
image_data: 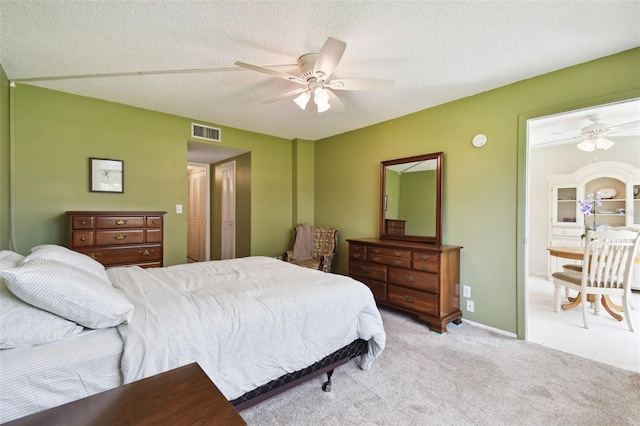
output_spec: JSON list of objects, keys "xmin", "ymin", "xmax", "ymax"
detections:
[{"xmin": 0, "ymin": 279, "xmax": 82, "ymax": 349}]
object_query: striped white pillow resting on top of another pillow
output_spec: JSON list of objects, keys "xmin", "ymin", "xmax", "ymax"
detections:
[{"xmin": 0, "ymin": 259, "xmax": 133, "ymax": 328}]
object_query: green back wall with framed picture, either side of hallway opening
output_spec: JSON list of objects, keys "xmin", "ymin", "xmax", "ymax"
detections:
[{"xmin": 8, "ymin": 84, "xmax": 291, "ymax": 265}]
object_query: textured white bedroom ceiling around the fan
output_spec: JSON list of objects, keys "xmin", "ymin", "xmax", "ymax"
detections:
[{"xmin": 0, "ymin": 0, "xmax": 640, "ymax": 142}]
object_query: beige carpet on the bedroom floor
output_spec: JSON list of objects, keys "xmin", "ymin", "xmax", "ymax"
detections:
[{"xmin": 240, "ymin": 308, "xmax": 640, "ymax": 425}]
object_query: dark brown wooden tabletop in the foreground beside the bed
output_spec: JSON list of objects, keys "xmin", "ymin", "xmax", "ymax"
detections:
[{"xmin": 6, "ymin": 363, "xmax": 246, "ymax": 426}]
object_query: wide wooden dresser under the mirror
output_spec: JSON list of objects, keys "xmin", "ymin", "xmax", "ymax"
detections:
[{"xmin": 347, "ymin": 238, "xmax": 462, "ymax": 333}]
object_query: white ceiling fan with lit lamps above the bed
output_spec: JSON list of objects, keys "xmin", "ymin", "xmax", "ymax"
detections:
[{"xmin": 235, "ymin": 37, "xmax": 395, "ymax": 112}]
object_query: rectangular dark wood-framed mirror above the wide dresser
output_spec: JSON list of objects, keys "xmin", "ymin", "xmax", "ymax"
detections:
[{"xmin": 380, "ymin": 152, "xmax": 444, "ymax": 244}]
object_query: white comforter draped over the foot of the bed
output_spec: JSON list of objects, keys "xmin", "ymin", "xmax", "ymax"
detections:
[{"xmin": 108, "ymin": 257, "xmax": 385, "ymax": 400}]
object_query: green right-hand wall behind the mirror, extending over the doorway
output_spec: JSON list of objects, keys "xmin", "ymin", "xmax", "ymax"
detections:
[{"xmin": 315, "ymin": 48, "xmax": 640, "ymax": 337}]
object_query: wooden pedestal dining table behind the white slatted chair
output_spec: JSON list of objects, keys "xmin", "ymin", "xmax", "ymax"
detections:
[{"xmin": 547, "ymin": 246, "xmax": 640, "ymax": 321}]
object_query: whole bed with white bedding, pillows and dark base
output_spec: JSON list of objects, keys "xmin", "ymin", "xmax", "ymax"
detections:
[{"xmin": 0, "ymin": 245, "xmax": 385, "ymax": 422}]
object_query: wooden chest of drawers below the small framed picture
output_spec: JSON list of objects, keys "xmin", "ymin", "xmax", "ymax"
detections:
[{"xmin": 67, "ymin": 211, "xmax": 167, "ymax": 268}]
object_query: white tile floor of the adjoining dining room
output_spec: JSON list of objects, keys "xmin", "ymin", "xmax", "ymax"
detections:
[{"xmin": 527, "ymin": 276, "xmax": 640, "ymax": 373}]
